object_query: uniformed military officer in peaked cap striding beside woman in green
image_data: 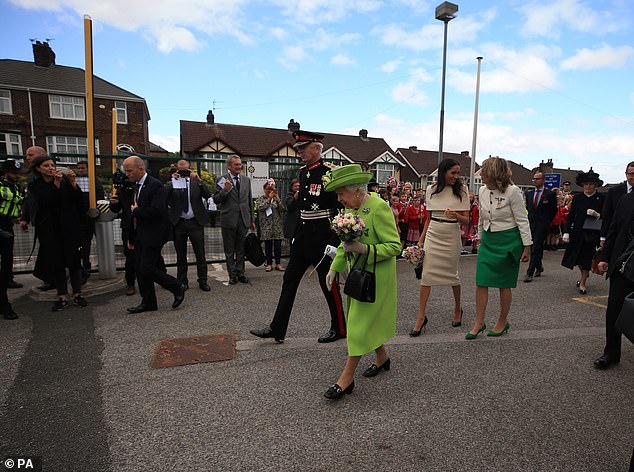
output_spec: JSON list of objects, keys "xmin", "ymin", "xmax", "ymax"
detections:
[{"xmin": 251, "ymin": 131, "xmax": 346, "ymax": 343}]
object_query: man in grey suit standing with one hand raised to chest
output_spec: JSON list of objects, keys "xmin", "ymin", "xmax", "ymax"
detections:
[{"xmin": 214, "ymin": 154, "xmax": 255, "ymax": 285}]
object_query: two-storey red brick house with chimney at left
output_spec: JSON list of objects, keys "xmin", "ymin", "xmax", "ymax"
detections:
[{"xmin": 0, "ymin": 41, "xmax": 150, "ymax": 162}]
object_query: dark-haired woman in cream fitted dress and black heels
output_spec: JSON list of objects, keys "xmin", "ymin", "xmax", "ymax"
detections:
[{"xmin": 409, "ymin": 159, "xmax": 469, "ymax": 336}]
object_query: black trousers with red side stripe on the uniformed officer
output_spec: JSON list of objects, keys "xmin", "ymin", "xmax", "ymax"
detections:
[{"xmin": 271, "ymin": 255, "xmax": 346, "ymax": 339}]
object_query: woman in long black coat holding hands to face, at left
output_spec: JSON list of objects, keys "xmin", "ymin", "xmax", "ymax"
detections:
[{"xmin": 29, "ymin": 155, "xmax": 87, "ymax": 311}]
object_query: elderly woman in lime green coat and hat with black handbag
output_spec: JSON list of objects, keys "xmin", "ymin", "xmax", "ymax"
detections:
[{"xmin": 324, "ymin": 164, "xmax": 401, "ymax": 400}]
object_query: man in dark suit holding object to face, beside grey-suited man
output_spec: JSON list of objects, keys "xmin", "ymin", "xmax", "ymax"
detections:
[{"xmin": 167, "ymin": 159, "xmax": 211, "ymax": 292}]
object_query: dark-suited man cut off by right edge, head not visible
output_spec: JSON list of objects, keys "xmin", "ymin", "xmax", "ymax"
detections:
[{"xmin": 594, "ymin": 187, "xmax": 634, "ymax": 369}]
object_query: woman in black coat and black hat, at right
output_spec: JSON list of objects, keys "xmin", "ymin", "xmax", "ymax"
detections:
[{"xmin": 561, "ymin": 167, "xmax": 605, "ymax": 295}]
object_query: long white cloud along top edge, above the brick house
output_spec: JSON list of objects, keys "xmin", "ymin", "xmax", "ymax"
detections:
[{"xmin": 10, "ymin": 0, "xmax": 253, "ymax": 53}]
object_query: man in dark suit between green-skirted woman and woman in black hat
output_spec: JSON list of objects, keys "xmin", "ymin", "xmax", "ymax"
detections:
[{"xmin": 524, "ymin": 172, "xmax": 557, "ymax": 282}]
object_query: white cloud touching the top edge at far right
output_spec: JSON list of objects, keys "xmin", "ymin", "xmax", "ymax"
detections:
[{"xmin": 518, "ymin": 0, "xmax": 626, "ymax": 38}]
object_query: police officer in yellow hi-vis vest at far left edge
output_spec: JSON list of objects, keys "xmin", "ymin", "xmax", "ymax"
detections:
[{"xmin": 0, "ymin": 159, "xmax": 24, "ymax": 320}]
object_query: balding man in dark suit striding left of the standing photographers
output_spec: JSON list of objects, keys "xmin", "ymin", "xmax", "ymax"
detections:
[{"xmin": 123, "ymin": 156, "xmax": 185, "ymax": 313}]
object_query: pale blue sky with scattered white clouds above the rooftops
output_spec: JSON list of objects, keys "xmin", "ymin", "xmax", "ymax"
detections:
[{"xmin": 0, "ymin": 0, "xmax": 634, "ymax": 182}]
